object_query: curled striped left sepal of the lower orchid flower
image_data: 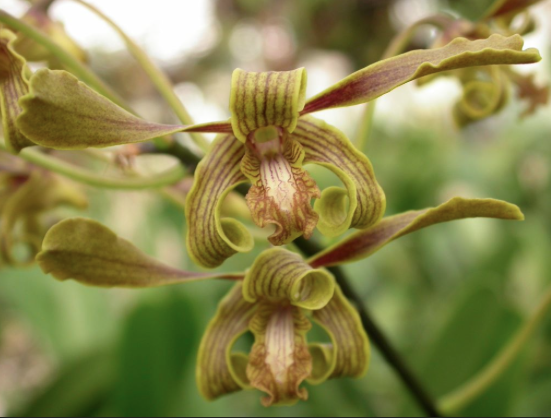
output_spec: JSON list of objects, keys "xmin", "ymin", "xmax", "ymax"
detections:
[{"xmin": 196, "ymin": 283, "xmax": 256, "ymax": 400}]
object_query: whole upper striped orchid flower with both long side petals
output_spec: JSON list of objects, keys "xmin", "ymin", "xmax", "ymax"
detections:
[{"xmin": 2, "ymin": 30, "xmax": 541, "ymax": 267}]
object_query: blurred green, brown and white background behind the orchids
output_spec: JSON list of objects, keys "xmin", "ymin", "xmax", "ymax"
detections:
[{"xmin": 0, "ymin": 0, "xmax": 551, "ymax": 416}]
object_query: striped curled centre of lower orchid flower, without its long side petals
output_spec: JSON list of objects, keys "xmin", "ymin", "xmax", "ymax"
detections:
[{"xmin": 197, "ymin": 248, "xmax": 370, "ymax": 406}]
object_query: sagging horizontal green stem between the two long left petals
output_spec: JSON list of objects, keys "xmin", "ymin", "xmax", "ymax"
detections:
[{"xmin": 0, "ymin": 142, "xmax": 186, "ymax": 190}]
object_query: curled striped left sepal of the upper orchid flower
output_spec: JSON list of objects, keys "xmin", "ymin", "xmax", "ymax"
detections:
[{"xmin": 186, "ymin": 135, "xmax": 254, "ymax": 268}]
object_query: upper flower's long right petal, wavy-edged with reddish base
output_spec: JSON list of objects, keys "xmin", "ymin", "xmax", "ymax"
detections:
[{"xmin": 302, "ymin": 35, "xmax": 541, "ymax": 114}]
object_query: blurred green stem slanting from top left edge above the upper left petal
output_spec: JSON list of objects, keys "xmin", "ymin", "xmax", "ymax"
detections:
[{"xmin": 0, "ymin": 10, "xmax": 128, "ymax": 109}]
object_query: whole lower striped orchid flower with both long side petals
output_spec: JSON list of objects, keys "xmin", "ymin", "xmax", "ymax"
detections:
[{"xmin": 37, "ymin": 198, "xmax": 524, "ymax": 406}]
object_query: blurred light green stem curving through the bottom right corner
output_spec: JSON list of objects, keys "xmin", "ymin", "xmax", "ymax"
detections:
[{"xmin": 439, "ymin": 289, "xmax": 551, "ymax": 415}]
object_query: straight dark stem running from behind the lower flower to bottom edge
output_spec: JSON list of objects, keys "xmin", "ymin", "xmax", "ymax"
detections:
[{"xmin": 294, "ymin": 237, "xmax": 442, "ymax": 417}]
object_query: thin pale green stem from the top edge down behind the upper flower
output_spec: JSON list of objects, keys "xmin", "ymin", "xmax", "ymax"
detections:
[{"xmin": 69, "ymin": 0, "xmax": 209, "ymax": 152}]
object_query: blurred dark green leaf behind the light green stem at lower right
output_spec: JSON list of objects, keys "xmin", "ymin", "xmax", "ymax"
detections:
[{"xmin": 422, "ymin": 280, "xmax": 524, "ymax": 416}]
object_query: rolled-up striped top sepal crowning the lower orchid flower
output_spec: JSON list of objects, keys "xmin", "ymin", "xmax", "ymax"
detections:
[{"xmin": 243, "ymin": 248, "xmax": 335, "ymax": 310}]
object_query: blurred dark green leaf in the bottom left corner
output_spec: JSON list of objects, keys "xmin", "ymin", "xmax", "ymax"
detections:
[{"xmin": 10, "ymin": 351, "xmax": 114, "ymax": 417}]
